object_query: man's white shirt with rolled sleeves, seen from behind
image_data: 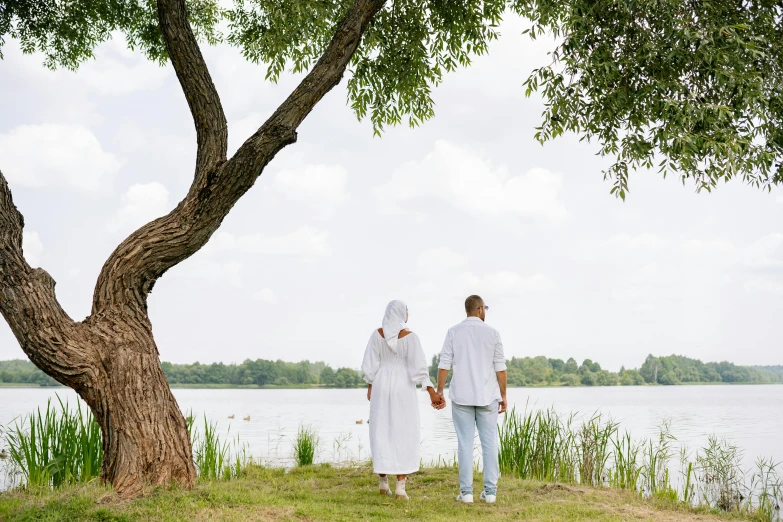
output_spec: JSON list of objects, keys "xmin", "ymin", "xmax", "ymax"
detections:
[{"xmin": 438, "ymin": 317, "xmax": 506, "ymax": 406}]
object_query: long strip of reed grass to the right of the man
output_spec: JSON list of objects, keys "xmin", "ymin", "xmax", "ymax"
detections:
[{"xmin": 498, "ymin": 409, "xmax": 783, "ymax": 521}]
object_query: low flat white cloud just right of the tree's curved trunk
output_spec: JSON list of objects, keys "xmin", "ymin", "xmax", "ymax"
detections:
[{"xmin": 203, "ymin": 227, "xmax": 330, "ymax": 257}]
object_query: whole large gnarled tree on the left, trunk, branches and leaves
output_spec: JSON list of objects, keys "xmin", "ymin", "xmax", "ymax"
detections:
[{"xmin": 0, "ymin": 0, "xmax": 506, "ymax": 496}]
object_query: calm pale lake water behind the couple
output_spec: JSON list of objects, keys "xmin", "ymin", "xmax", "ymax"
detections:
[{"xmin": 0, "ymin": 385, "xmax": 783, "ymax": 486}]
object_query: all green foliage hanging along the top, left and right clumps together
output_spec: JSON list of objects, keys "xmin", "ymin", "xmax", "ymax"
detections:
[{"xmin": 7, "ymin": 0, "xmax": 783, "ymax": 198}]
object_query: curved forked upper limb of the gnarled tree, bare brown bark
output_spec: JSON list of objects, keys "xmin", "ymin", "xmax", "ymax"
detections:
[{"xmin": 93, "ymin": 0, "xmax": 386, "ymax": 314}]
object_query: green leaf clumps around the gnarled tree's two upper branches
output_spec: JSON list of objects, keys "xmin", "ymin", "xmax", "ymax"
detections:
[{"xmin": 0, "ymin": 0, "xmax": 506, "ymax": 133}]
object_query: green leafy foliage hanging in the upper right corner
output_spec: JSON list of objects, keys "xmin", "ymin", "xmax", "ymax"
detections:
[{"xmin": 511, "ymin": 0, "xmax": 783, "ymax": 199}]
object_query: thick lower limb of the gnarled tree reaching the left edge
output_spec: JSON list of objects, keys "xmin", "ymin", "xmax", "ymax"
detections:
[{"xmin": 0, "ymin": 172, "xmax": 93, "ymax": 389}]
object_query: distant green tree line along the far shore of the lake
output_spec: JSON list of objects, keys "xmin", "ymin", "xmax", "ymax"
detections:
[{"xmin": 0, "ymin": 355, "xmax": 783, "ymax": 388}]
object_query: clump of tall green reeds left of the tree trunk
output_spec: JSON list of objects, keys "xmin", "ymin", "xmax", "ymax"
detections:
[{"xmin": 6, "ymin": 396, "xmax": 103, "ymax": 487}]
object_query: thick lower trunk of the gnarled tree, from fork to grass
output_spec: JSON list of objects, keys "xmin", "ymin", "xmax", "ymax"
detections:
[{"xmin": 77, "ymin": 310, "xmax": 196, "ymax": 497}]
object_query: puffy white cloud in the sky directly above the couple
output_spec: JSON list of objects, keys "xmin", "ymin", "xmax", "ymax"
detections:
[{"xmin": 375, "ymin": 140, "xmax": 568, "ymax": 222}]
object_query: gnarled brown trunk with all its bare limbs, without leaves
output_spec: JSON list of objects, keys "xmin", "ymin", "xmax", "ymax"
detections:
[{"xmin": 0, "ymin": 0, "xmax": 385, "ymax": 496}]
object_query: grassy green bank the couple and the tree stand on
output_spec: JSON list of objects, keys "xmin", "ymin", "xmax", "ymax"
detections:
[{"xmin": 0, "ymin": 465, "xmax": 751, "ymax": 522}]
